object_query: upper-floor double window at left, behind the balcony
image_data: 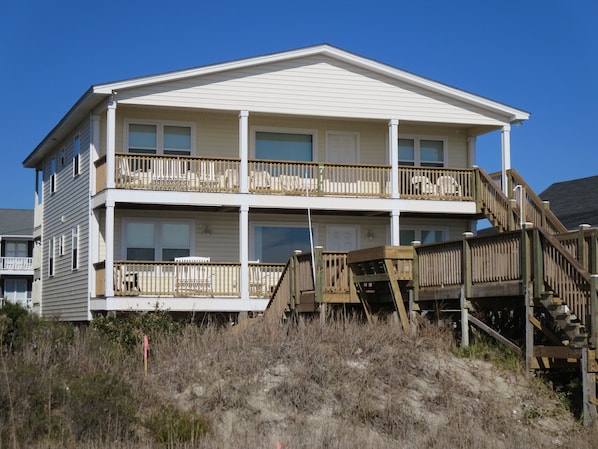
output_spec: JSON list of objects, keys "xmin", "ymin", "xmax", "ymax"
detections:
[{"xmin": 126, "ymin": 123, "xmax": 193, "ymax": 156}]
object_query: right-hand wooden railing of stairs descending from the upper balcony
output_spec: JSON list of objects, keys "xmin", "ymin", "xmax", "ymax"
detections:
[{"xmin": 489, "ymin": 168, "xmax": 567, "ymax": 234}]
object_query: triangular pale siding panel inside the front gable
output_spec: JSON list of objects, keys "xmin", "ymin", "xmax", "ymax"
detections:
[{"xmin": 118, "ymin": 55, "xmax": 509, "ymax": 125}]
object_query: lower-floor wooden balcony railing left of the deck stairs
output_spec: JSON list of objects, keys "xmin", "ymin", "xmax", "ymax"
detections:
[{"xmin": 112, "ymin": 261, "xmax": 284, "ymax": 298}]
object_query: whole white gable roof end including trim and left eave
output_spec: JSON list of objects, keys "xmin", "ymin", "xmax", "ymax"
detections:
[{"xmin": 24, "ymin": 44, "xmax": 529, "ymax": 167}]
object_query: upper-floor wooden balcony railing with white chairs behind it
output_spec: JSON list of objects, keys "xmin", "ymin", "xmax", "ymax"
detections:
[{"xmin": 101, "ymin": 154, "xmax": 475, "ymax": 201}]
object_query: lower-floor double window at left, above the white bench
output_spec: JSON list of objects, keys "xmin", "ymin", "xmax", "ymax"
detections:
[{"xmin": 124, "ymin": 221, "xmax": 192, "ymax": 261}]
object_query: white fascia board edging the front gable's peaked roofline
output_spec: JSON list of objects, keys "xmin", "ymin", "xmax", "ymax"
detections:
[{"xmin": 93, "ymin": 45, "xmax": 530, "ymax": 123}]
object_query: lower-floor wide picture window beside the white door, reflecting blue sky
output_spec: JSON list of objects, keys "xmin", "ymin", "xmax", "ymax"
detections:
[{"xmin": 253, "ymin": 225, "xmax": 311, "ymax": 263}]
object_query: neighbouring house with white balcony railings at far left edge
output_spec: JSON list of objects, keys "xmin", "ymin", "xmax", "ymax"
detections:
[{"xmin": 0, "ymin": 209, "xmax": 33, "ymax": 309}]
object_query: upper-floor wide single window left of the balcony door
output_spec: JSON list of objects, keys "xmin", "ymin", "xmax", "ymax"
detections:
[{"xmin": 255, "ymin": 131, "xmax": 314, "ymax": 161}]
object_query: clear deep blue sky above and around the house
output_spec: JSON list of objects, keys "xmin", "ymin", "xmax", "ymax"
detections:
[{"xmin": 0, "ymin": 0, "xmax": 598, "ymax": 208}]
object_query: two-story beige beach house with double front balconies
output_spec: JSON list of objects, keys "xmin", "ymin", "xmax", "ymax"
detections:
[{"xmin": 24, "ymin": 45, "xmax": 529, "ymax": 320}]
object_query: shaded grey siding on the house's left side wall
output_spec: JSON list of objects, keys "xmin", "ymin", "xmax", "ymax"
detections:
[{"xmin": 42, "ymin": 121, "xmax": 90, "ymax": 321}]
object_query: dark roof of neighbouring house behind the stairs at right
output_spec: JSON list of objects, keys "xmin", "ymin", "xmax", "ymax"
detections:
[{"xmin": 539, "ymin": 176, "xmax": 598, "ymax": 230}]
